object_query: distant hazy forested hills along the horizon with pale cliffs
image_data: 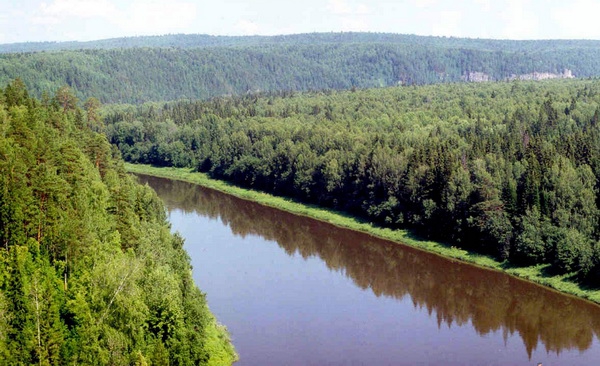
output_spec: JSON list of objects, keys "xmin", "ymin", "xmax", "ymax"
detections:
[{"xmin": 0, "ymin": 33, "xmax": 600, "ymax": 103}]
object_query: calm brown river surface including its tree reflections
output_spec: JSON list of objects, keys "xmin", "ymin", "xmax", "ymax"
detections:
[{"xmin": 140, "ymin": 176, "xmax": 600, "ymax": 366}]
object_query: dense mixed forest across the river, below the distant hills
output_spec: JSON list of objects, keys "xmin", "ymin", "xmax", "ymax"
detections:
[{"xmin": 104, "ymin": 81, "xmax": 600, "ymax": 284}]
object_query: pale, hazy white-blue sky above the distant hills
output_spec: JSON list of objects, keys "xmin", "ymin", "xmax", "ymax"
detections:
[{"xmin": 0, "ymin": 0, "xmax": 600, "ymax": 43}]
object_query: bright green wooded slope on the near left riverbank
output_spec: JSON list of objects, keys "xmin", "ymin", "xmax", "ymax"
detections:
[{"xmin": 0, "ymin": 80, "xmax": 235, "ymax": 365}]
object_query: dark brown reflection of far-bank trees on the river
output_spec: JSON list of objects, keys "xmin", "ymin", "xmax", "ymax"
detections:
[{"xmin": 140, "ymin": 176, "xmax": 600, "ymax": 357}]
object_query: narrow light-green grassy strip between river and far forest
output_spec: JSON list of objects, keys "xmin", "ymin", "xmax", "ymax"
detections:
[{"xmin": 126, "ymin": 164, "xmax": 600, "ymax": 303}]
